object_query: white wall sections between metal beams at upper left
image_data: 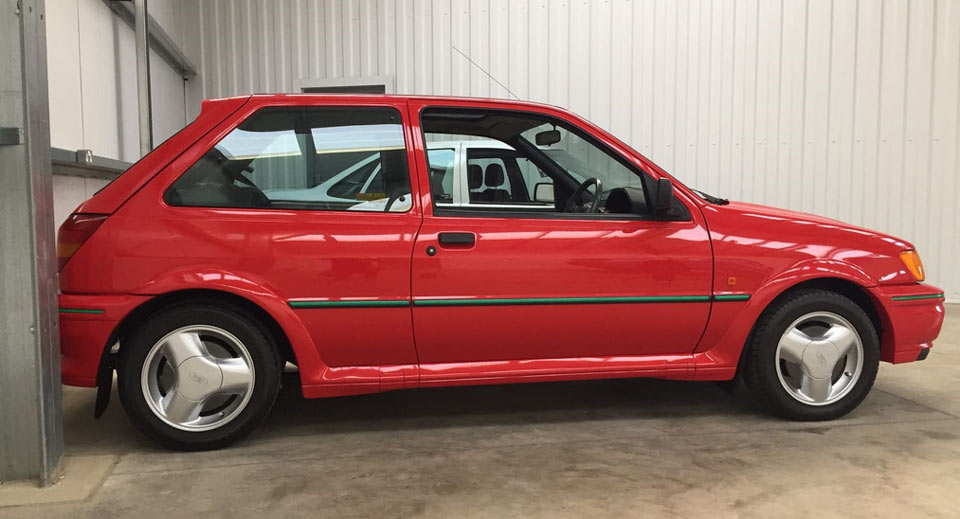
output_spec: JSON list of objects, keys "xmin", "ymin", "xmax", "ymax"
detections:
[{"xmin": 46, "ymin": 0, "xmax": 188, "ymax": 226}]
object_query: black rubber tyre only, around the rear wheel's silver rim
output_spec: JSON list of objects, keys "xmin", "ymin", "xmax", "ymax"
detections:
[{"xmin": 117, "ymin": 301, "xmax": 283, "ymax": 451}]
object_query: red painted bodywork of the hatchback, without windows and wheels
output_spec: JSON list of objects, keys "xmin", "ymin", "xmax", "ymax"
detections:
[{"xmin": 54, "ymin": 95, "xmax": 943, "ymax": 397}]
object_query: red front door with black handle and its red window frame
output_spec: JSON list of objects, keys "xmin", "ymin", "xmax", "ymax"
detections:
[{"xmin": 410, "ymin": 100, "xmax": 713, "ymax": 366}]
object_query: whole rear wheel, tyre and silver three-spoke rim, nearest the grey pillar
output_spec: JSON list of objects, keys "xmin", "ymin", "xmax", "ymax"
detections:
[{"xmin": 117, "ymin": 301, "xmax": 283, "ymax": 451}]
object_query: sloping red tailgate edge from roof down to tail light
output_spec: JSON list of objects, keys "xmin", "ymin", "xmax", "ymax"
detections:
[{"xmin": 74, "ymin": 95, "xmax": 251, "ymax": 214}]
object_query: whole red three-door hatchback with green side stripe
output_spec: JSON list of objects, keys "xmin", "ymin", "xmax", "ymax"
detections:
[{"xmin": 57, "ymin": 95, "xmax": 944, "ymax": 449}]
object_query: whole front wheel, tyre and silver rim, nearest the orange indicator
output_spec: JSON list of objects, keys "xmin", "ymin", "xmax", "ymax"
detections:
[{"xmin": 744, "ymin": 289, "xmax": 880, "ymax": 421}]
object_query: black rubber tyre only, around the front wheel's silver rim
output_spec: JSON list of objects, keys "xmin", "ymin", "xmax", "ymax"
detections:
[{"xmin": 744, "ymin": 289, "xmax": 880, "ymax": 421}]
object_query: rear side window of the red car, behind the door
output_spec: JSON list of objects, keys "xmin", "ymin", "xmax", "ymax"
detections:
[{"xmin": 164, "ymin": 107, "xmax": 412, "ymax": 212}]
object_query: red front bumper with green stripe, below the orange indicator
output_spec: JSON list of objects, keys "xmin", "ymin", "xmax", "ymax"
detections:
[{"xmin": 869, "ymin": 284, "xmax": 944, "ymax": 364}]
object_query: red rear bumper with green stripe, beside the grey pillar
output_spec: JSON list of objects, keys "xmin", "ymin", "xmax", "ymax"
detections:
[{"xmin": 60, "ymin": 294, "xmax": 149, "ymax": 387}]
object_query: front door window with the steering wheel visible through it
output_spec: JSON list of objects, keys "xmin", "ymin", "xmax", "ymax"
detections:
[{"xmin": 421, "ymin": 107, "xmax": 649, "ymax": 217}]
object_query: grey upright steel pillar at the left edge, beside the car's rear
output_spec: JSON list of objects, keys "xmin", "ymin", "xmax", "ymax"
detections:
[{"xmin": 0, "ymin": 0, "xmax": 63, "ymax": 485}]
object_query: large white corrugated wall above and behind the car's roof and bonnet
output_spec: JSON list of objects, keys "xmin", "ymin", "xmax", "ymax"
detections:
[{"xmin": 183, "ymin": 0, "xmax": 960, "ymax": 301}]
